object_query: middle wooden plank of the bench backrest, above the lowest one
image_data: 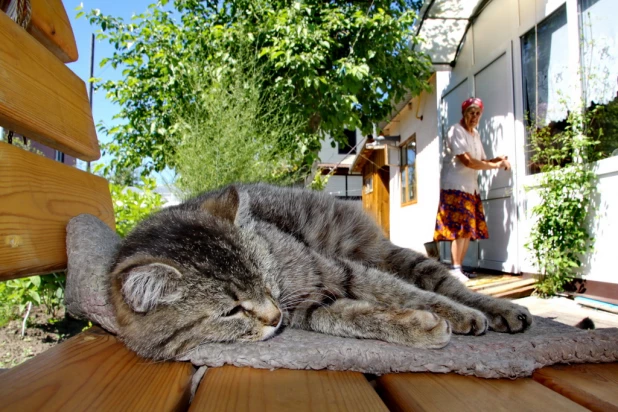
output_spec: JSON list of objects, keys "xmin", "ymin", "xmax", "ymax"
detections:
[{"xmin": 0, "ymin": 13, "xmax": 100, "ymax": 161}]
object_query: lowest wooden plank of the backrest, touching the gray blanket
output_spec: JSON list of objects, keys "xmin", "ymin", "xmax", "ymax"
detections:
[{"xmin": 0, "ymin": 143, "xmax": 115, "ymax": 280}]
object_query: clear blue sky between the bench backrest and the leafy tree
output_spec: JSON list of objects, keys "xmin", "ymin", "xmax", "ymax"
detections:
[{"xmin": 63, "ymin": 0, "xmax": 166, "ymax": 172}]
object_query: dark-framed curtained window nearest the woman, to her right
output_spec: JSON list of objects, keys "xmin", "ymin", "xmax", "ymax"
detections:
[{"xmin": 521, "ymin": 4, "xmax": 570, "ymax": 173}]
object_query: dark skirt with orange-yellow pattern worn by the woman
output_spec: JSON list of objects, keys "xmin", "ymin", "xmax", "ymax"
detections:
[{"xmin": 433, "ymin": 190, "xmax": 489, "ymax": 242}]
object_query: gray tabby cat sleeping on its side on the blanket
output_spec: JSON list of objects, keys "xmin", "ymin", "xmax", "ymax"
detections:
[{"xmin": 110, "ymin": 184, "xmax": 532, "ymax": 359}]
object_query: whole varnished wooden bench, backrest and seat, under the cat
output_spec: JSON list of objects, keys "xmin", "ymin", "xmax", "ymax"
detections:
[{"xmin": 0, "ymin": 0, "xmax": 618, "ymax": 411}]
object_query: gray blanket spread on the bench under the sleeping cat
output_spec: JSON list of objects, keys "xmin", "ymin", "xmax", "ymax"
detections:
[{"xmin": 65, "ymin": 215, "xmax": 618, "ymax": 378}]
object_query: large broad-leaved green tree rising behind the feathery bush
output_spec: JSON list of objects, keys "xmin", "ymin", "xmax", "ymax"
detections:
[{"xmin": 82, "ymin": 0, "xmax": 430, "ymax": 174}]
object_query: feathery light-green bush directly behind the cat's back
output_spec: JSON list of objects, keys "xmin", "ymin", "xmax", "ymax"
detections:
[{"xmin": 175, "ymin": 52, "xmax": 304, "ymax": 198}]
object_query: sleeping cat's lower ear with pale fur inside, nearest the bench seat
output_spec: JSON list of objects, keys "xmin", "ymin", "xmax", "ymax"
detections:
[{"xmin": 122, "ymin": 262, "xmax": 182, "ymax": 313}]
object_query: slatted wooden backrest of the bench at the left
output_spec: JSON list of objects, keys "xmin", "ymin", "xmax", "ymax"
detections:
[{"xmin": 0, "ymin": 0, "xmax": 115, "ymax": 280}]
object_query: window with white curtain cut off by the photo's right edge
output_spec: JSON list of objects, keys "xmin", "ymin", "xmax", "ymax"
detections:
[{"xmin": 579, "ymin": 0, "xmax": 618, "ymax": 158}]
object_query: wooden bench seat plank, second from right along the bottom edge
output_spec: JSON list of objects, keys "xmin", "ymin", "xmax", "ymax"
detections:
[{"xmin": 377, "ymin": 373, "xmax": 585, "ymax": 412}]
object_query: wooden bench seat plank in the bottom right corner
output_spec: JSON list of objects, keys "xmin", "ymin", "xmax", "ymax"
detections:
[{"xmin": 532, "ymin": 363, "xmax": 618, "ymax": 412}]
